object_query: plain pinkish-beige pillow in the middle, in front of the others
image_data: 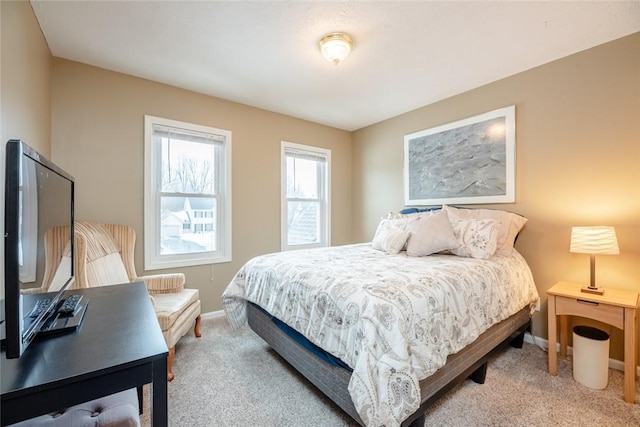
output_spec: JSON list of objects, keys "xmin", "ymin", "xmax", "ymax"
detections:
[{"xmin": 407, "ymin": 211, "xmax": 459, "ymax": 256}]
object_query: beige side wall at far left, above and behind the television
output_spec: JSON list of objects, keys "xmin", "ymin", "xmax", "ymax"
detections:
[{"xmin": 0, "ymin": 0, "xmax": 51, "ymax": 294}]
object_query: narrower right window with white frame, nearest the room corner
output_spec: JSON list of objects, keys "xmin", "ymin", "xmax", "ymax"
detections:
[{"xmin": 281, "ymin": 141, "xmax": 331, "ymax": 250}]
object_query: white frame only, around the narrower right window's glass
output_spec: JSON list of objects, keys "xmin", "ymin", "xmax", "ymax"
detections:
[{"xmin": 280, "ymin": 141, "xmax": 331, "ymax": 251}]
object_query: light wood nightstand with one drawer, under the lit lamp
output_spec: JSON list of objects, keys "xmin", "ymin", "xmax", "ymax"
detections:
[{"xmin": 547, "ymin": 282, "xmax": 638, "ymax": 403}]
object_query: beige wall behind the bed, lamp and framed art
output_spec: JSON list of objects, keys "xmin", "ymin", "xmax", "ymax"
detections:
[{"xmin": 352, "ymin": 33, "xmax": 640, "ymax": 359}]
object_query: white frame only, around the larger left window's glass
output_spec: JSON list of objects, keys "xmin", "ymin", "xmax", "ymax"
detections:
[{"xmin": 144, "ymin": 115, "xmax": 232, "ymax": 270}]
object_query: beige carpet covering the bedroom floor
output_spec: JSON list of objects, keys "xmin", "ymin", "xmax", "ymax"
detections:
[{"xmin": 142, "ymin": 318, "xmax": 640, "ymax": 427}]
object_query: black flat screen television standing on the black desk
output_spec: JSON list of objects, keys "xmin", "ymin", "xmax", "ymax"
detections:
[{"xmin": 2, "ymin": 140, "xmax": 74, "ymax": 358}]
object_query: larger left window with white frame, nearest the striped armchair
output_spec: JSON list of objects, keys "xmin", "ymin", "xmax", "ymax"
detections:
[{"xmin": 144, "ymin": 116, "xmax": 231, "ymax": 270}]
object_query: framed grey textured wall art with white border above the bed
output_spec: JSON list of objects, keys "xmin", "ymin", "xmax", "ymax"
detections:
[{"xmin": 404, "ymin": 105, "xmax": 516, "ymax": 206}]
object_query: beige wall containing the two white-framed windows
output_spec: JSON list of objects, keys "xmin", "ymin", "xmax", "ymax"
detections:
[{"xmin": 52, "ymin": 59, "xmax": 351, "ymax": 312}]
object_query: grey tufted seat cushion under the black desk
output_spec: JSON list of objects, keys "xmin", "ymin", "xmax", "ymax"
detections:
[{"xmin": 11, "ymin": 388, "xmax": 140, "ymax": 427}]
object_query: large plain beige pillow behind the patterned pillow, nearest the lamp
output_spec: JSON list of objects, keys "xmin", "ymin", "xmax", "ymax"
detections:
[{"xmin": 442, "ymin": 205, "xmax": 528, "ymax": 255}]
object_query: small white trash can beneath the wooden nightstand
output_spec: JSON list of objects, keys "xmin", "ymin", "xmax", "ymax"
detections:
[{"xmin": 573, "ymin": 326, "xmax": 609, "ymax": 390}]
